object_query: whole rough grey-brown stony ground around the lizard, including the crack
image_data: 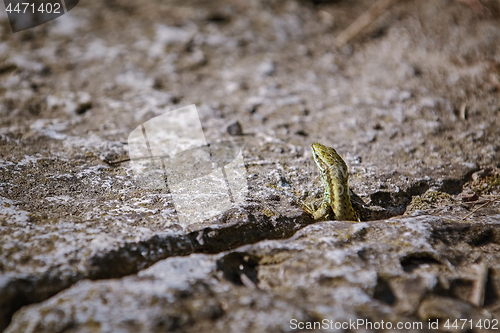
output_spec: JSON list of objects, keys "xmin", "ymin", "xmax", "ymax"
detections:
[{"xmin": 0, "ymin": 0, "xmax": 500, "ymax": 333}]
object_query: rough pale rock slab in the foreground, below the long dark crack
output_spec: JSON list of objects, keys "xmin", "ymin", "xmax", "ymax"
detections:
[{"xmin": 7, "ymin": 215, "xmax": 500, "ymax": 332}]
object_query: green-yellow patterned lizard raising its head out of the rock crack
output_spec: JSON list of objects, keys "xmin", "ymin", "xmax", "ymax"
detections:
[{"xmin": 302, "ymin": 142, "xmax": 359, "ymax": 222}]
